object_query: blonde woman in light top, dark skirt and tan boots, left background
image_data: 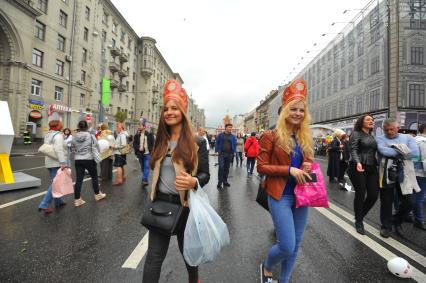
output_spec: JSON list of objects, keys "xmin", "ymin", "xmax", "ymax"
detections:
[{"xmin": 112, "ymin": 122, "xmax": 127, "ymax": 186}]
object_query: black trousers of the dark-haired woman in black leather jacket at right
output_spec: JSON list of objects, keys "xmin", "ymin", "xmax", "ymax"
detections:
[{"xmin": 348, "ymin": 162, "xmax": 379, "ymax": 222}]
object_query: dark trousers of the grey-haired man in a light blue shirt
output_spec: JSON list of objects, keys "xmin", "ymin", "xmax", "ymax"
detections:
[{"xmin": 380, "ymin": 183, "xmax": 413, "ymax": 230}]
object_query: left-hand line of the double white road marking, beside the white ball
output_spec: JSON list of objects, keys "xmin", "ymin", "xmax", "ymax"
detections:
[{"xmin": 316, "ymin": 208, "xmax": 426, "ymax": 282}]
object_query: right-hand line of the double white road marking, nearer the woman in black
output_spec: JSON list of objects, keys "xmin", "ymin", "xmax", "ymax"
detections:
[{"xmin": 330, "ymin": 203, "xmax": 426, "ymax": 267}]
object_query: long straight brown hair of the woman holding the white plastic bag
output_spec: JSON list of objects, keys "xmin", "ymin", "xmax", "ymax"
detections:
[{"xmin": 149, "ymin": 105, "xmax": 198, "ymax": 172}]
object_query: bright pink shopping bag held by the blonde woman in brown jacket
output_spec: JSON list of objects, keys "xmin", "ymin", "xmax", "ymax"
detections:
[{"xmin": 294, "ymin": 162, "xmax": 329, "ymax": 208}]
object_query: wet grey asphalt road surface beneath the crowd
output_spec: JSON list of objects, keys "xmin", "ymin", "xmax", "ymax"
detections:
[{"xmin": 0, "ymin": 156, "xmax": 426, "ymax": 282}]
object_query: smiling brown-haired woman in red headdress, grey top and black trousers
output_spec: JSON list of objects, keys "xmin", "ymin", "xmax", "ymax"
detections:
[{"xmin": 142, "ymin": 80, "xmax": 210, "ymax": 283}]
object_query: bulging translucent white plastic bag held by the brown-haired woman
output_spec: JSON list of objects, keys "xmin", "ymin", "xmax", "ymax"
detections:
[{"xmin": 183, "ymin": 186, "xmax": 230, "ymax": 266}]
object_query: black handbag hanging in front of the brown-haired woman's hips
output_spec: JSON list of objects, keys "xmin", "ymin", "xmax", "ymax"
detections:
[{"xmin": 141, "ymin": 191, "xmax": 188, "ymax": 236}]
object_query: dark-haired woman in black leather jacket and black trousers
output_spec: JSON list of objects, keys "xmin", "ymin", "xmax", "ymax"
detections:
[{"xmin": 348, "ymin": 115, "xmax": 379, "ymax": 235}]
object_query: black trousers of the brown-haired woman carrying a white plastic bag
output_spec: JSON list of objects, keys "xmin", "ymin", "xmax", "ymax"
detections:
[{"xmin": 142, "ymin": 209, "xmax": 198, "ymax": 283}]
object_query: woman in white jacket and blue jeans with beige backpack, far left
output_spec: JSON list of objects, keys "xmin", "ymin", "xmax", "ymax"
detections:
[{"xmin": 38, "ymin": 112, "xmax": 68, "ymax": 215}]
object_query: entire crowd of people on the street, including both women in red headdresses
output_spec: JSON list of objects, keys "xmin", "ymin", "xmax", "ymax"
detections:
[{"xmin": 35, "ymin": 79, "xmax": 426, "ymax": 283}]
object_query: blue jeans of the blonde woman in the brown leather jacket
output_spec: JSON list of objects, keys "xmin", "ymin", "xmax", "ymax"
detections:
[{"xmin": 265, "ymin": 195, "xmax": 308, "ymax": 283}]
